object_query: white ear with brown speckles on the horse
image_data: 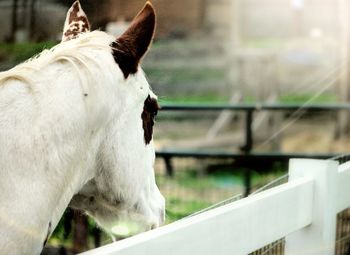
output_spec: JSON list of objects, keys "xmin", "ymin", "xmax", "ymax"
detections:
[{"xmin": 62, "ymin": 0, "xmax": 90, "ymax": 42}]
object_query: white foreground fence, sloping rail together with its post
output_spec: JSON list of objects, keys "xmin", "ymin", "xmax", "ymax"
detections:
[{"xmin": 83, "ymin": 160, "xmax": 350, "ymax": 255}]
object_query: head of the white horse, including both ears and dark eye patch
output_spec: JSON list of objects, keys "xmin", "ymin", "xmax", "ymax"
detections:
[{"xmin": 62, "ymin": 1, "xmax": 164, "ymax": 237}]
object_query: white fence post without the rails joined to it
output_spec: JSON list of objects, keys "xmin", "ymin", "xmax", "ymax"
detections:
[{"xmin": 285, "ymin": 159, "xmax": 338, "ymax": 255}]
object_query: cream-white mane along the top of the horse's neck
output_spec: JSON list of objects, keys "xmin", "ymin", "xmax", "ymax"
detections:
[{"xmin": 0, "ymin": 31, "xmax": 113, "ymax": 86}]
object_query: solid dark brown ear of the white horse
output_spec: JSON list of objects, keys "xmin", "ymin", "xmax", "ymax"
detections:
[{"xmin": 112, "ymin": 2, "xmax": 156, "ymax": 79}]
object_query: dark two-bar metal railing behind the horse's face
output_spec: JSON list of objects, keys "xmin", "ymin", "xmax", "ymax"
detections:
[{"xmin": 156, "ymin": 103, "xmax": 350, "ymax": 195}]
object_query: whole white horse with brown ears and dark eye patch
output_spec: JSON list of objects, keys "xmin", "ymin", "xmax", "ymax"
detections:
[{"xmin": 0, "ymin": 1, "xmax": 164, "ymax": 255}]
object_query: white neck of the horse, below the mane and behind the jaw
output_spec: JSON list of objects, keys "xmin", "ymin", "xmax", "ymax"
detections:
[{"xmin": 0, "ymin": 61, "xmax": 106, "ymax": 254}]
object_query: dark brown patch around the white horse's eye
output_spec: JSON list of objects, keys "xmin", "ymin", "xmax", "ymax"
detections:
[{"xmin": 141, "ymin": 96, "xmax": 160, "ymax": 145}]
